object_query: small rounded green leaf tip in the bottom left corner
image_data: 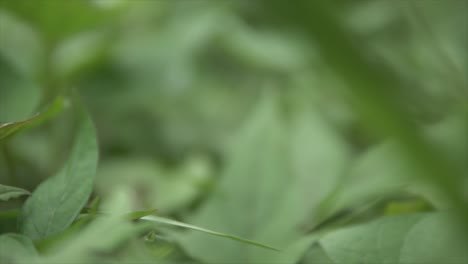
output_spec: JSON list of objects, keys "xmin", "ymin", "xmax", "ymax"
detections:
[{"xmin": 0, "ymin": 234, "xmax": 37, "ymax": 263}]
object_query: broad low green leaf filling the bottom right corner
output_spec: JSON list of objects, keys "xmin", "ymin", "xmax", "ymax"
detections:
[{"xmin": 320, "ymin": 213, "xmax": 468, "ymax": 264}]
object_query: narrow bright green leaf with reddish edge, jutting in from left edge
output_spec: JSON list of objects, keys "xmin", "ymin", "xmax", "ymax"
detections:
[{"xmin": 0, "ymin": 97, "xmax": 63, "ymax": 141}]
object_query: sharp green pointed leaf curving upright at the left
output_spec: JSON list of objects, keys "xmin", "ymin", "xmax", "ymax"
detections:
[{"xmin": 20, "ymin": 108, "xmax": 98, "ymax": 239}]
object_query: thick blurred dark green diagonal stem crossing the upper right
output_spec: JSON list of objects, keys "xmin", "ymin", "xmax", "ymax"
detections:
[{"xmin": 263, "ymin": 0, "xmax": 468, "ymax": 227}]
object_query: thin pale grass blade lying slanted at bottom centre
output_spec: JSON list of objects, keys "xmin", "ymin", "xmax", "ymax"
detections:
[{"xmin": 140, "ymin": 215, "xmax": 279, "ymax": 251}]
